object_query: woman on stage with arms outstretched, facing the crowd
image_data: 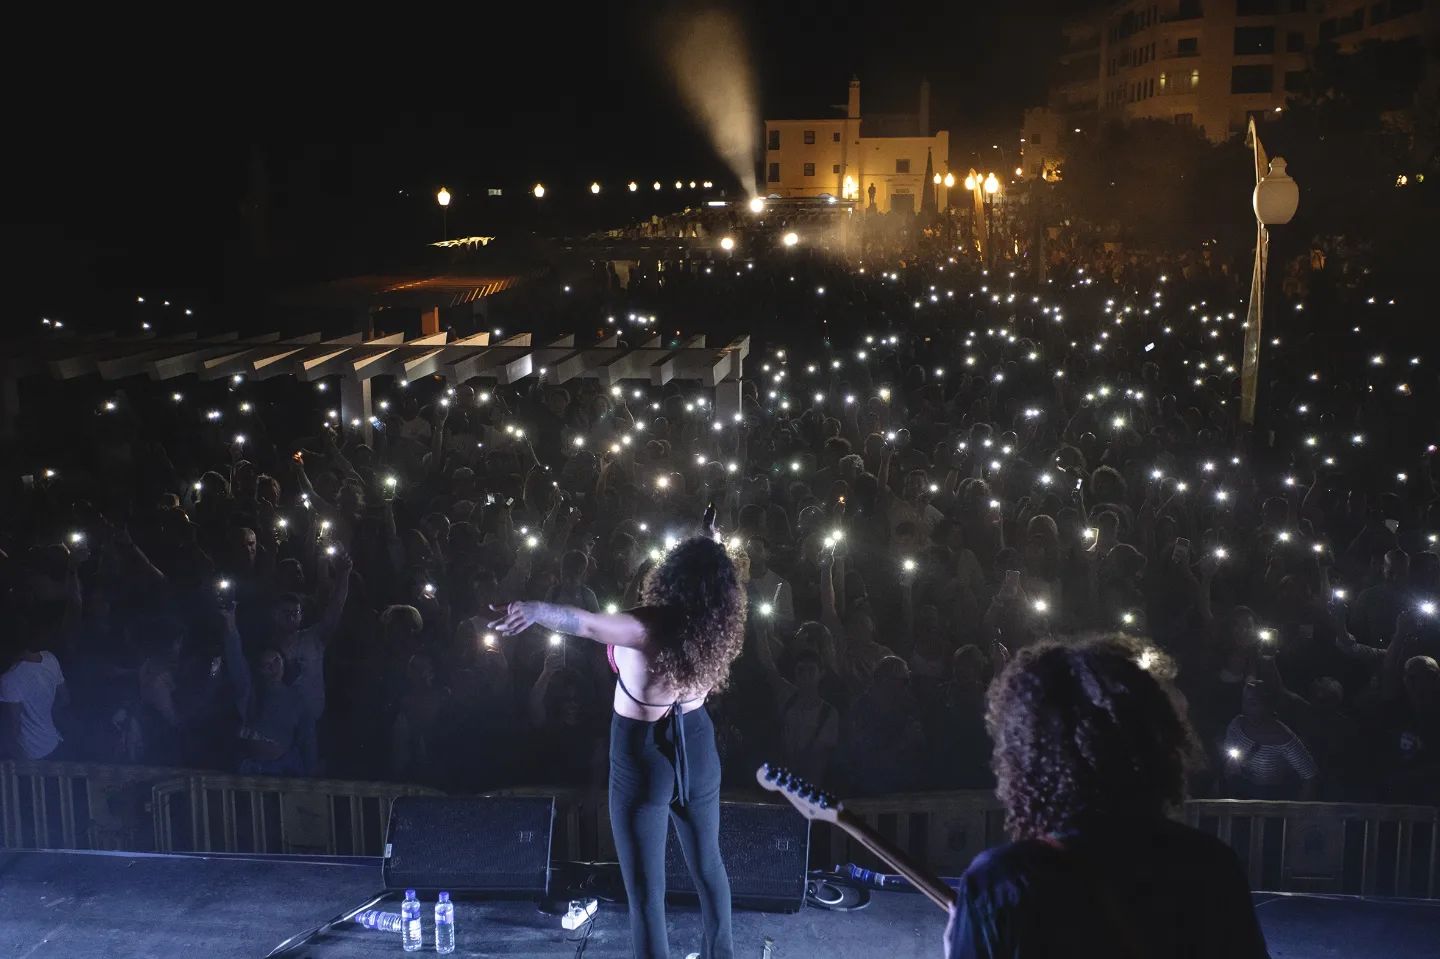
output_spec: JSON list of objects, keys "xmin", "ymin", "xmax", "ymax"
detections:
[{"xmin": 490, "ymin": 508, "xmax": 744, "ymax": 959}]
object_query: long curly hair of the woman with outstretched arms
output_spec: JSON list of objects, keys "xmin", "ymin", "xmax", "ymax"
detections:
[{"xmin": 641, "ymin": 536, "xmax": 746, "ymax": 691}]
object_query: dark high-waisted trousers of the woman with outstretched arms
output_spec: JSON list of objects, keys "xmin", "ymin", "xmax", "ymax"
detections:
[{"xmin": 611, "ymin": 707, "xmax": 734, "ymax": 959}]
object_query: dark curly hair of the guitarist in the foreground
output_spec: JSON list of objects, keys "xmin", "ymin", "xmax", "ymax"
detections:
[{"xmin": 985, "ymin": 636, "xmax": 1195, "ymax": 838}]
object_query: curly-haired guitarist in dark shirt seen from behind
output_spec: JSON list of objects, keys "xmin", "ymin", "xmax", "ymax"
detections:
[{"xmin": 945, "ymin": 639, "xmax": 1267, "ymax": 959}]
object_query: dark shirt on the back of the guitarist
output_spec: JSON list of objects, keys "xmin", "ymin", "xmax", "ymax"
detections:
[{"xmin": 946, "ymin": 819, "xmax": 1269, "ymax": 959}]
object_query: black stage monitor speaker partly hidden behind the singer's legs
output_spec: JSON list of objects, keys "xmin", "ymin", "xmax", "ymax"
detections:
[{"xmin": 665, "ymin": 802, "xmax": 809, "ymax": 913}]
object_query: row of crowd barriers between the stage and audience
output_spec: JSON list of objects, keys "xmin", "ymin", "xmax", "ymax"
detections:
[{"xmin": 0, "ymin": 762, "xmax": 1440, "ymax": 899}]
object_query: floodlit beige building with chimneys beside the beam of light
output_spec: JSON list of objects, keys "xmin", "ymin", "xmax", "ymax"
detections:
[{"xmin": 763, "ymin": 79, "xmax": 950, "ymax": 213}]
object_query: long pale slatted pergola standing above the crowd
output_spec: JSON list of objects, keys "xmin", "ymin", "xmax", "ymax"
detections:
[{"xmin": 0, "ymin": 331, "xmax": 750, "ymax": 442}]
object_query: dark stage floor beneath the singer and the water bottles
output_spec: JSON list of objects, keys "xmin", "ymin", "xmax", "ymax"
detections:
[{"xmin": 0, "ymin": 850, "xmax": 1440, "ymax": 959}]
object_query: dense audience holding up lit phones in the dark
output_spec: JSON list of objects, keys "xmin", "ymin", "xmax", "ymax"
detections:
[{"xmin": 0, "ymin": 233, "xmax": 1440, "ymax": 802}]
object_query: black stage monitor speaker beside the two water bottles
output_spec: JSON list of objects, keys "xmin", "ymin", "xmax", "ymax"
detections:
[{"xmin": 382, "ymin": 796, "xmax": 554, "ymax": 899}]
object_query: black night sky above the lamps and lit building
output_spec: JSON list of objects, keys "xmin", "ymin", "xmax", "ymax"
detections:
[{"xmin": 0, "ymin": 0, "xmax": 1074, "ymax": 319}]
